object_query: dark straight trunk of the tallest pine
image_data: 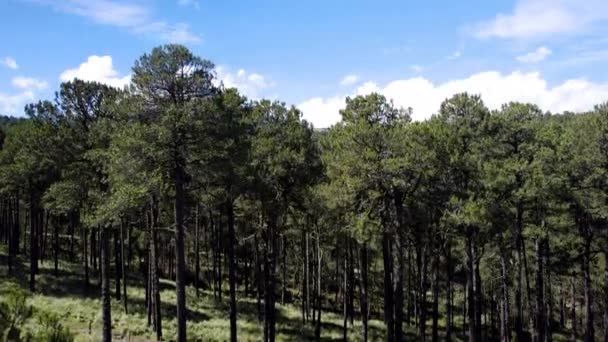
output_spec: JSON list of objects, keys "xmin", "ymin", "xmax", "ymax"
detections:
[{"xmin": 174, "ymin": 161, "xmax": 187, "ymax": 342}]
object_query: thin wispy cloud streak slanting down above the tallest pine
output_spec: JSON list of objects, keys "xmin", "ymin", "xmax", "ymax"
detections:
[{"xmin": 35, "ymin": 0, "xmax": 201, "ymax": 43}]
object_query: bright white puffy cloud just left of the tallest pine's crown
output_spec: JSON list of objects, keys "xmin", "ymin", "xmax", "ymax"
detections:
[{"xmin": 59, "ymin": 56, "xmax": 131, "ymax": 88}]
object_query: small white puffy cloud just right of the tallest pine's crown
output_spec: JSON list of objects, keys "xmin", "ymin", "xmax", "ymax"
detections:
[{"xmin": 216, "ymin": 66, "xmax": 275, "ymax": 99}]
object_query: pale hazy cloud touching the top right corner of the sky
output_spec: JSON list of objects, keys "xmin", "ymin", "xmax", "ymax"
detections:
[{"xmin": 473, "ymin": 0, "xmax": 608, "ymax": 38}]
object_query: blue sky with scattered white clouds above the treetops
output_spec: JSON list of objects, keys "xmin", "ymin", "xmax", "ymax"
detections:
[{"xmin": 0, "ymin": 0, "xmax": 608, "ymax": 127}]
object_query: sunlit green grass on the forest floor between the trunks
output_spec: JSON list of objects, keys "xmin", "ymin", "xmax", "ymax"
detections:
[{"xmin": 0, "ymin": 249, "xmax": 580, "ymax": 341}]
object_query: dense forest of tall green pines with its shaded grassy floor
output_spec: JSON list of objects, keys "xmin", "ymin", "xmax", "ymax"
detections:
[{"xmin": 0, "ymin": 45, "xmax": 608, "ymax": 342}]
